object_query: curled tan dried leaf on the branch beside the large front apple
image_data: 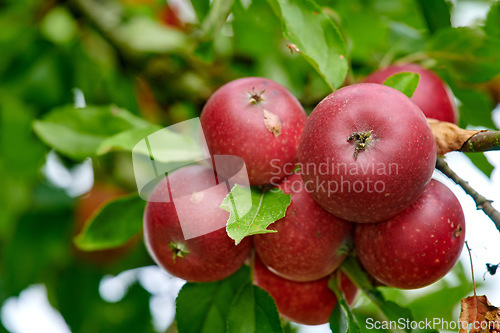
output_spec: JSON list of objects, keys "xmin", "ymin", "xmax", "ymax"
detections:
[{"xmin": 427, "ymin": 118, "xmax": 481, "ymax": 155}]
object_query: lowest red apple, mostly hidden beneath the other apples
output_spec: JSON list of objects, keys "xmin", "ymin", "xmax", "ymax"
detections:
[{"xmin": 253, "ymin": 256, "xmax": 358, "ymax": 325}]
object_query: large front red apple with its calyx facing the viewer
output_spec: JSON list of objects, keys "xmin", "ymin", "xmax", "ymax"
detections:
[{"xmin": 299, "ymin": 83, "xmax": 436, "ymax": 223}]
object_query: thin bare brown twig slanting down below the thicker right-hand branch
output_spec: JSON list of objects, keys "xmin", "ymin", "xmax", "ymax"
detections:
[{"xmin": 436, "ymin": 157, "xmax": 500, "ymax": 231}]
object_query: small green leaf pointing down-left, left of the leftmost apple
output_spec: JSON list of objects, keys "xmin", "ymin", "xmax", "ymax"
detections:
[{"xmin": 74, "ymin": 194, "xmax": 145, "ymax": 251}]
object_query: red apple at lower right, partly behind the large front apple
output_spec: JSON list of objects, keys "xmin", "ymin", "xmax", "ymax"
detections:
[{"xmin": 355, "ymin": 180, "xmax": 465, "ymax": 289}]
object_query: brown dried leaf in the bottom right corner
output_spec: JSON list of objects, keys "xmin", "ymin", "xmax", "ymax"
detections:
[{"xmin": 459, "ymin": 295, "xmax": 500, "ymax": 333}]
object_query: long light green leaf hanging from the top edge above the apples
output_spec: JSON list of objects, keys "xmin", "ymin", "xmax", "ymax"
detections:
[{"xmin": 271, "ymin": 0, "xmax": 348, "ymax": 90}]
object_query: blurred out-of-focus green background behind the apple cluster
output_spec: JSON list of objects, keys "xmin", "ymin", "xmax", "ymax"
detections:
[{"xmin": 0, "ymin": 0, "xmax": 500, "ymax": 333}]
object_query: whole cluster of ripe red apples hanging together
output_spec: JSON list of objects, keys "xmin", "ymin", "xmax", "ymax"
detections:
[{"xmin": 144, "ymin": 64, "xmax": 465, "ymax": 325}]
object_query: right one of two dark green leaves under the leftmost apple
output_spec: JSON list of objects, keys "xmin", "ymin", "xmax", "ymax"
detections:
[{"xmin": 227, "ymin": 283, "xmax": 283, "ymax": 333}]
